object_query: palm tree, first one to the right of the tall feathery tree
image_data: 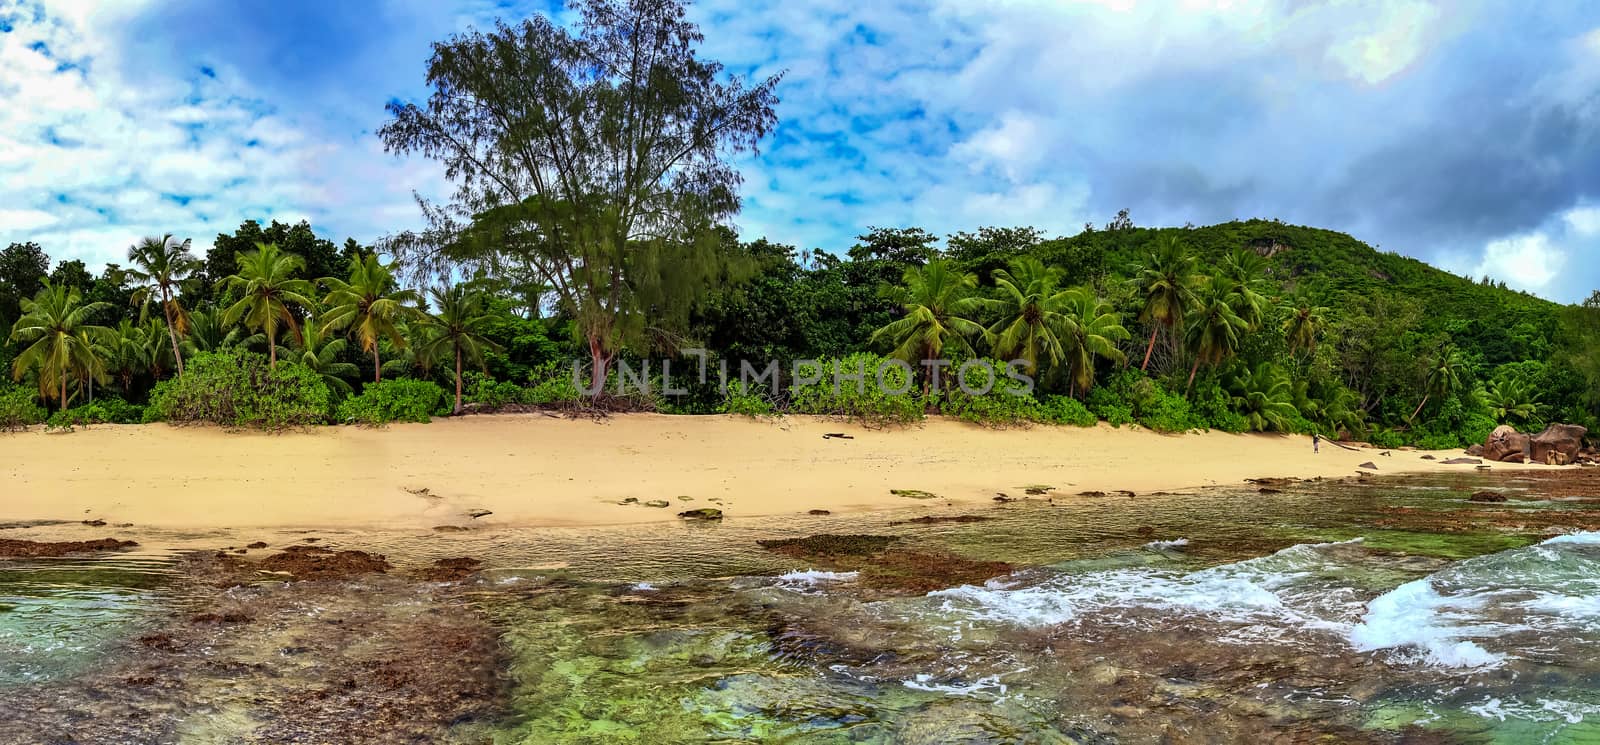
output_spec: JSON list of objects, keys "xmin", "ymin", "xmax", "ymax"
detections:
[{"xmin": 872, "ymin": 259, "xmax": 987, "ymax": 393}]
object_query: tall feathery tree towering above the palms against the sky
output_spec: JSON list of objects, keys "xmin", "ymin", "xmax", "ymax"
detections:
[{"xmin": 379, "ymin": 0, "xmax": 779, "ymax": 393}]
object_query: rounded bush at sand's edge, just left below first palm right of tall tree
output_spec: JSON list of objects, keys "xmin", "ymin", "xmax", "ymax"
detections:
[{"xmin": 790, "ymin": 352, "xmax": 925, "ymax": 424}]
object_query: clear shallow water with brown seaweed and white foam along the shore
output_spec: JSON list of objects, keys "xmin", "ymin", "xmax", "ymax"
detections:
[{"xmin": 0, "ymin": 472, "xmax": 1600, "ymax": 743}]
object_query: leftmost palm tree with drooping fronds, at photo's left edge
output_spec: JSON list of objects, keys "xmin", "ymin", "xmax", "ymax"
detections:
[{"xmin": 11, "ymin": 280, "xmax": 115, "ymax": 411}]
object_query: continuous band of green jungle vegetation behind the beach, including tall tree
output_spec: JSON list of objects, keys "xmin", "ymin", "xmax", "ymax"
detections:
[{"xmin": 0, "ymin": 0, "xmax": 1600, "ymax": 448}]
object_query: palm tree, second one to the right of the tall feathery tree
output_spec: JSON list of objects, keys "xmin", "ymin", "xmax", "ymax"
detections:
[{"xmin": 979, "ymin": 256, "xmax": 1067, "ymax": 380}]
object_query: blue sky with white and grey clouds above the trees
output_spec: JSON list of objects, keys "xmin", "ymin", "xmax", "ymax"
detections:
[{"xmin": 0, "ymin": 0, "xmax": 1600, "ymax": 302}]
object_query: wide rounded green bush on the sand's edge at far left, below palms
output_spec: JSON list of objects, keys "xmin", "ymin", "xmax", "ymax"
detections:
[{"xmin": 142, "ymin": 350, "xmax": 331, "ymax": 428}]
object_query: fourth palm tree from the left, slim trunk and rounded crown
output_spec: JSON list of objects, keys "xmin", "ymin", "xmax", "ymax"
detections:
[{"xmin": 322, "ymin": 254, "xmax": 419, "ymax": 382}]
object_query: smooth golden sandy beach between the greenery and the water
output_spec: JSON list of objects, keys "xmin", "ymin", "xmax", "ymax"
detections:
[{"xmin": 0, "ymin": 414, "xmax": 1542, "ymax": 529}]
